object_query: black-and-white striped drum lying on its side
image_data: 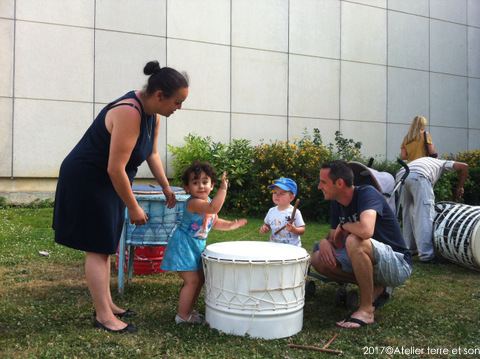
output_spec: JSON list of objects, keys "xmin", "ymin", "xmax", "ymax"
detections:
[{"xmin": 433, "ymin": 202, "xmax": 480, "ymax": 270}]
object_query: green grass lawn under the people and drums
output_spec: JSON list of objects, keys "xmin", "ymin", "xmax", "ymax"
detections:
[{"xmin": 0, "ymin": 208, "xmax": 480, "ymax": 359}]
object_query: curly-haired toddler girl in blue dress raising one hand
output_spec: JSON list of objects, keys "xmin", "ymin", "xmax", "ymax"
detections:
[{"xmin": 160, "ymin": 161, "xmax": 247, "ymax": 324}]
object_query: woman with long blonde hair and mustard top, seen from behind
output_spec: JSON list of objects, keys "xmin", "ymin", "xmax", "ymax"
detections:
[{"xmin": 400, "ymin": 116, "xmax": 435, "ymax": 162}]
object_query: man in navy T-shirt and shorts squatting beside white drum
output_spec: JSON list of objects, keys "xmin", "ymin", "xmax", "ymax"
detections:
[{"xmin": 312, "ymin": 160, "xmax": 412, "ymax": 328}]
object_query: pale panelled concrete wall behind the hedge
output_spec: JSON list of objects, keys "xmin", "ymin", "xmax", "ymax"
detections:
[{"xmin": 0, "ymin": 0, "xmax": 480, "ymax": 202}]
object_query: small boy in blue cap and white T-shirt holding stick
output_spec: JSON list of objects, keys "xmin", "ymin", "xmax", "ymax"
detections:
[{"xmin": 260, "ymin": 177, "xmax": 305, "ymax": 247}]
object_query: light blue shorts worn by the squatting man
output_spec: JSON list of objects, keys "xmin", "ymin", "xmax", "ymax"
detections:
[{"xmin": 335, "ymin": 238, "xmax": 412, "ymax": 287}]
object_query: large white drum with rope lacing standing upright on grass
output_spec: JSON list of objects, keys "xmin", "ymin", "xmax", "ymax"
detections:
[{"xmin": 202, "ymin": 241, "xmax": 310, "ymax": 339}]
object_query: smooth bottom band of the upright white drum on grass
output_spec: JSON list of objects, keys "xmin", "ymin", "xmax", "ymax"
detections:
[{"xmin": 205, "ymin": 304, "xmax": 303, "ymax": 339}]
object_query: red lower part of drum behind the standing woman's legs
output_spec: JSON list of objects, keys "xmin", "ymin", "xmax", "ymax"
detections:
[{"xmin": 115, "ymin": 246, "xmax": 166, "ymax": 275}]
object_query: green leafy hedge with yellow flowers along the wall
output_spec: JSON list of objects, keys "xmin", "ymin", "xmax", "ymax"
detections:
[{"xmin": 168, "ymin": 129, "xmax": 480, "ymax": 221}]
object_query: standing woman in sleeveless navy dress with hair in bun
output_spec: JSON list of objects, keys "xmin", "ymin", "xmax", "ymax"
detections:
[{"xmin": 53, "ymin": 61, "xmax": 188, "ymax": 333}]
